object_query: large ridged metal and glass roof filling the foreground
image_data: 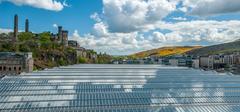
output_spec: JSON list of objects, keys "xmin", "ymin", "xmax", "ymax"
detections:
[{"xmin": 0, "ymin": 65, "xmax": 240, "ymax": 112}]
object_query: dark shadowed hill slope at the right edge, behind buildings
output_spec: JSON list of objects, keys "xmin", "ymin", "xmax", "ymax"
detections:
[{"xmin": 187, "ymin": 40, "xmax": 240, "ymax": 56}]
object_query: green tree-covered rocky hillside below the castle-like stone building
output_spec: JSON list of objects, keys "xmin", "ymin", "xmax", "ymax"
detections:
[{"xmin": 0, "ymin": 32, "xmax": 111, "ymax": 69}]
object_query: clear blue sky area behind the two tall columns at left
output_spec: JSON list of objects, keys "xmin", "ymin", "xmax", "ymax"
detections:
[{"xmin": 0, "ymin": 0, "xmax": 102, "ymax": 34}]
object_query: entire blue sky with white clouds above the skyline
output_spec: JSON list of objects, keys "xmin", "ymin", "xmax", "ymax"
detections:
[{"xmin": 0, "ymin": 0, "xmax": 240, "ymax": 55}]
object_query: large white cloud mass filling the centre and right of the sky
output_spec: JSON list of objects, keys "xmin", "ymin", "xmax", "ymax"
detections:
[{"xmin": 68, "ymin": 0, "xmax": 240, "ymax": 55}]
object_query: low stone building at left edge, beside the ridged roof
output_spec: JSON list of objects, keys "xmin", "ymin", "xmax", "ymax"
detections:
[{"xmin": 0, "ymin": 52, "xmax": 33, "ymax": 76}]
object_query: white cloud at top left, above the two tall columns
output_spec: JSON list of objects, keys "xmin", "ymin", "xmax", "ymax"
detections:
[{"xmin": 0, "ymin": 0, "xmax": 68, "ymax": 11}]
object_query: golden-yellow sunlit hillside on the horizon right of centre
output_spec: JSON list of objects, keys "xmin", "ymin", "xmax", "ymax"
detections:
[{"xmin": 130, "ymin": 46, "xmax": 201, "ymax": 58}]
